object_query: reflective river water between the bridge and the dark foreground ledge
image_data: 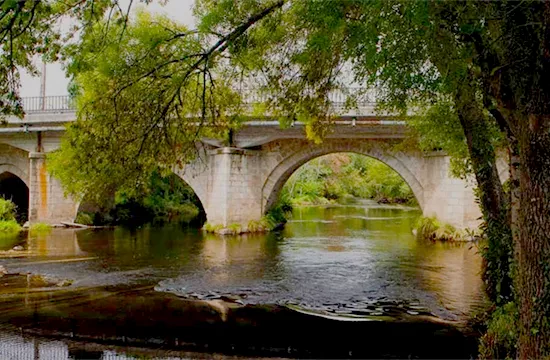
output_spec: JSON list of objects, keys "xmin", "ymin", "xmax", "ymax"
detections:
[{"xmin": 0, "ymin": 205, "xmax": 484, "ymax": 320}]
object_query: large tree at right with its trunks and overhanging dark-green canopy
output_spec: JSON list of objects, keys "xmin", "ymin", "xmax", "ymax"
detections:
[{"xmin": 193, "ymin": 0, "xmax": 550, "ymax": 358}]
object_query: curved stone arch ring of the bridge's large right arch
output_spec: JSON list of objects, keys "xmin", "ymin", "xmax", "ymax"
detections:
[{"xmin": 262, "ymin": 142, "xmax": 424, "ymax": 212}]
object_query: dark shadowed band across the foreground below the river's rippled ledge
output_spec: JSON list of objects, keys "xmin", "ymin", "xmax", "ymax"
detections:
[{"xmin": 0, "ymin": 276, "xmax": 477, "ymax": 358}]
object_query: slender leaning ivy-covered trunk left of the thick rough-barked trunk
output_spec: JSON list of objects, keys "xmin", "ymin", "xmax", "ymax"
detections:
[{"xmin": 455, "ymin": 73, "xmax": 513, "ymax": 304}]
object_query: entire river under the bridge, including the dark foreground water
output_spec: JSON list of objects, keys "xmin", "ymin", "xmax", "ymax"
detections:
[{"xmin": 0, "ymin": 203, "xmax": 485, "ymax": 359}]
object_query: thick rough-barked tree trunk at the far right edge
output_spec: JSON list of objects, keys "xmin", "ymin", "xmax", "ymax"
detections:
[{"xmin": 516, "ymin": 119, "xmax": 550, "ymax": 359}]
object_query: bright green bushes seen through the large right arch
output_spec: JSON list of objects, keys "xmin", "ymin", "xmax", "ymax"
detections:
[{"xmin": 282, "ymin": 154, "xmax": 415, "ymax": 204}]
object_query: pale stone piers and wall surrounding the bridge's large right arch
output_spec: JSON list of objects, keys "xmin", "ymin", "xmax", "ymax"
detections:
[{"xmin": 180, "ymin": 139, "xmax": 480, "ymax": 231}]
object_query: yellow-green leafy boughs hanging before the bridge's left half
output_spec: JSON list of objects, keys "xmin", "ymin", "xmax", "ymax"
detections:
[{"xmin": 49, "ymin": 12, "xmax": 242, "ymax": 203}]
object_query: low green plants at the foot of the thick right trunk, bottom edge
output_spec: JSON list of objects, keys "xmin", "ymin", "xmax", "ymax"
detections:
[{"xmin": 479, "ymin": 302, "xmax": 519, "ymax": 359}]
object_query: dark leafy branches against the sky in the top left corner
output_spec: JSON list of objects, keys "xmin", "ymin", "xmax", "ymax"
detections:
[{"xmin": 0, "ymin": 0, "xmax": 157, "ymax": 120}]
